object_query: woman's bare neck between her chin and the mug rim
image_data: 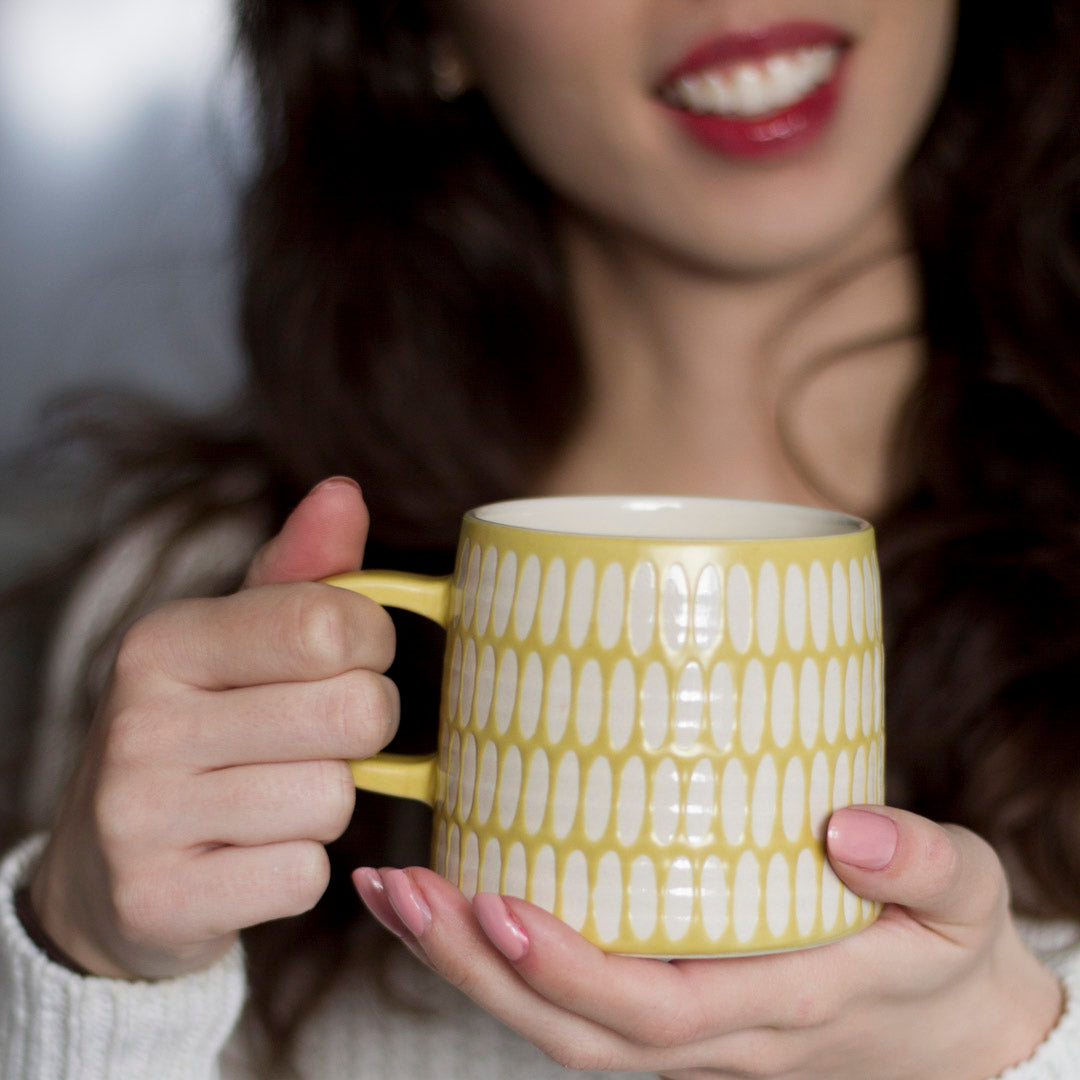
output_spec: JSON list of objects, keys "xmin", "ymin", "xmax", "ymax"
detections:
[{"xmin": 543, "ymin": 195, "xmax": 919, "ymax": 513}]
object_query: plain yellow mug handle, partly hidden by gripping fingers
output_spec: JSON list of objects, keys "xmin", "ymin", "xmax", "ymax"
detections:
[{"xmin": 323, "ymin": 570, "xmax": 451, "ymax": 807}]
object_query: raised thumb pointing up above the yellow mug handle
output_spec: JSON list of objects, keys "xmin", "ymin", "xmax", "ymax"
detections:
[{"xmin": 244, "ymin": 476, "xmax": 368, "ymax": 588}]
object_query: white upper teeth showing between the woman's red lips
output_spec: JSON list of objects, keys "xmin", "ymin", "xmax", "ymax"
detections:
[{"xmin": 663, "ymin": 44, "xmax": 840, "ymax": 117}]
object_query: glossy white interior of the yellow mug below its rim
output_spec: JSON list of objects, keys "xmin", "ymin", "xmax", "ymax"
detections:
[{"xmin": 470, "ymin": 495, "xmax": 869, "ymax": 541}]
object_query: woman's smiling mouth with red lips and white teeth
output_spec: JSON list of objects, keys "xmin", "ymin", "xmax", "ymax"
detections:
[{"xmin": 658, "ymin": 23, "xmax": 849, "ymax": 158}]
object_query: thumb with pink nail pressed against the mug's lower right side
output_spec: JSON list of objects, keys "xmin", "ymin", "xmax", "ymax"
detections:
[{"xmin": 826, "ymin": 806, "xmax": 1008, "ymax": 932}]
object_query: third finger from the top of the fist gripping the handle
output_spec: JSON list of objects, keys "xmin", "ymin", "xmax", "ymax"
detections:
[{"xmin": 178, "ymin": 760, "xmax": 356, "ymax": 848}]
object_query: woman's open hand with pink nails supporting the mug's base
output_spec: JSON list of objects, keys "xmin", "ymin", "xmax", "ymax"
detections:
[{"xmin": 354, "ymin": 807, "xmax": 1062, "ymax": 1080}]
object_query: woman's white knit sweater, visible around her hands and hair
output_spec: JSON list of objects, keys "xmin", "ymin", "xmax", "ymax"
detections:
[{"xmin": 0, "ymin": 507, "xmax": 1080, "ymax": 1080}]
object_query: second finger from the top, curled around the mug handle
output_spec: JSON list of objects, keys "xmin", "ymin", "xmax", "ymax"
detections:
[{"xmin": 168, "ymin": 669, "xmax": 401, "ymax": 771}]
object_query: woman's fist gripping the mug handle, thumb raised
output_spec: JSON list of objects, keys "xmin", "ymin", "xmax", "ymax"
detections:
[{"xmin": 30, "ymin": 478, "xmax": 397, "ymax": 978}]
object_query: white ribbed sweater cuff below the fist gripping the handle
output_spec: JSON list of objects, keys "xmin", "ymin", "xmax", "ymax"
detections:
[{"xmin": 0, "ymin": 836, "xmax": 245, "ymax": 1080}]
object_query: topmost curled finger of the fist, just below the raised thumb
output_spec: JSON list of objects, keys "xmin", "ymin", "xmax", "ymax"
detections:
[{"xmin": 116, "ymin": 582, "xmax": 394, "ymax": 690}]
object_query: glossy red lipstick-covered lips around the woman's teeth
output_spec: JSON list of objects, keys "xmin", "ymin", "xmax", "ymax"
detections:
[{"xmin": 661, "ymin": 22, "xmax": 851, "ymax": 160}]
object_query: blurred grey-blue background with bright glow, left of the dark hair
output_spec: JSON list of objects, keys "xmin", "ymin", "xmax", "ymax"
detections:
[{"xmin": 0, "ymin": 0, "xmax": 247, "ymax": 578}]
